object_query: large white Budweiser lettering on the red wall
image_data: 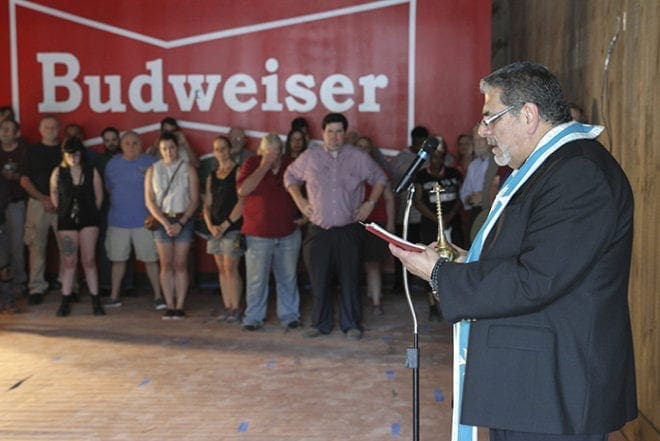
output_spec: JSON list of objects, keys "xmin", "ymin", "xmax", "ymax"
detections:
[{"xmin": 37, "ymin": 52, "xmax": 389, "ymax": 113}]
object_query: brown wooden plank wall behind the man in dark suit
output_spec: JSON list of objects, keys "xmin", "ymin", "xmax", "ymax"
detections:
[{"xmin": 493, "ymin": 0, "xmax": 660, "ymax": 441}]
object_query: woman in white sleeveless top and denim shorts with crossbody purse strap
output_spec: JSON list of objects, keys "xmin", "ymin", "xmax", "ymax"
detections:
[{"xmin": 144, "ymin": 132, "xmax": 199, "ymax": 320}]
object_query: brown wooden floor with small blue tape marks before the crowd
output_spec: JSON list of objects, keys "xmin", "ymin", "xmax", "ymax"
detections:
[{"xmin": 0, "ymin": 291, "xmax": 622, "ymax": 441}]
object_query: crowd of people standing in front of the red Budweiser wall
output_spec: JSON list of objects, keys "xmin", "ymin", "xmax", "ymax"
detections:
[{"xmin": 0, "ymin": 109, "xmax": 498, "ymax": 339}]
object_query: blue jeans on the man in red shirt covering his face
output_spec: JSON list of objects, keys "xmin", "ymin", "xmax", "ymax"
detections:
[{"xmin": 243, "ymin": 229, "xmax": 301, "ymax": 326}]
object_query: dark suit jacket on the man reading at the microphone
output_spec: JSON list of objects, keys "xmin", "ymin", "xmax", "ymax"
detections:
[{"xmin": 437, "ymin": 140, "xmax": 637, "ymax": 434}]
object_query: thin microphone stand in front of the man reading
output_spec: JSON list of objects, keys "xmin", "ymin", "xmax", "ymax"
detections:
[{"xmin": 402, "ymin": 183, "xmax": 419, "ymax": 441}]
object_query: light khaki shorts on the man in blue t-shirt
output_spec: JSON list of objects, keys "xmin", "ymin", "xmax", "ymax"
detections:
[{"xmin": 105, "ymin": 227, "xmax": 158, "ymax": 263}]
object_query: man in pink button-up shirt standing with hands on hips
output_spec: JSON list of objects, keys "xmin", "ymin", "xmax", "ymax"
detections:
[{"xmin": 284, "ymin": 113, "xmax": 387, "ymax": 340}]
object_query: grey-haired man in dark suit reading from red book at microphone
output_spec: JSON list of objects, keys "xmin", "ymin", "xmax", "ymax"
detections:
[{"xmin": 390, "ymin": 62, "xmax": 637, "ymax": 441}]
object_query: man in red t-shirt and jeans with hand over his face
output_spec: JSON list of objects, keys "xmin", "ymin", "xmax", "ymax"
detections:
[{"xmin": 236, "ymin": 133, "xmax": 301, "ymax": 331}]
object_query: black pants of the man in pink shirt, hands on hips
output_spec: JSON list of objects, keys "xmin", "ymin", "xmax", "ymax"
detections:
[{"xmin": 303, "ymin": 224, "xmax": 364, "ymax": 334}]
